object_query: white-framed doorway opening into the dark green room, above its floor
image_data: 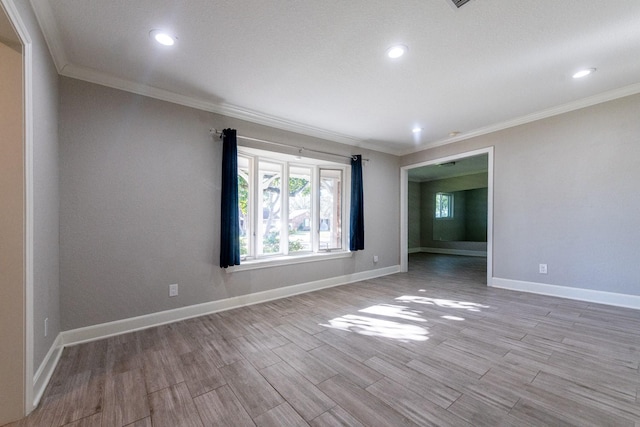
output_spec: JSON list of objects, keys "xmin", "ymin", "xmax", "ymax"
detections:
[{"xmin": 400, "ymin": 147, "xmax": 493, "ymax": 285}]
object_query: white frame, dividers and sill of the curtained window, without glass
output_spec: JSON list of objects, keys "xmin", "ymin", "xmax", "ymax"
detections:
[{"xmin": 226, "ymin": 147, "xmax": 352, "ymax": 272}]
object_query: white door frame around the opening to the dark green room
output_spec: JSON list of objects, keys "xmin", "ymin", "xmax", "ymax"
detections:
[{"xmin": 400, "ymin": 146, "xmax": 493, "ymax": 286}]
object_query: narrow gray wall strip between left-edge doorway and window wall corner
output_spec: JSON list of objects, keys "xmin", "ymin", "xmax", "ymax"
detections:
[{"xmin": 15, "ymin": 1, "xmax": 61, "ymax": 372}]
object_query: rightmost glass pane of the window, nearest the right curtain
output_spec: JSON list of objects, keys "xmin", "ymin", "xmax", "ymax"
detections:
[{"xmin": 319, "ymin": 169, "xmax": 342, "ymax": 250}]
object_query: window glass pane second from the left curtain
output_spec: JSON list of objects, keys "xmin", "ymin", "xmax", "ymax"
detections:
[{"xmin": 259, "ymin": 161, "xmax": 282, "ymax": 254}]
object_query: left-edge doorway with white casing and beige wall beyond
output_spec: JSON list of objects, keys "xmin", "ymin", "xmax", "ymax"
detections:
[{"xmin": 0, "ymin": 0, "xmax": 34, "ymax": 425}]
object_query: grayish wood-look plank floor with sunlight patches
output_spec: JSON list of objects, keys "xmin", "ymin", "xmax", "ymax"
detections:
[{"xmin": 11, "ymin": 254, "xmax": 640, "ymax": 427}]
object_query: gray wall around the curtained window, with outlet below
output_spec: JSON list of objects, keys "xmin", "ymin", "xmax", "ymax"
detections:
[{"xmin": 59, "ymin": 78, "xmax": 400, "ymax": 330}]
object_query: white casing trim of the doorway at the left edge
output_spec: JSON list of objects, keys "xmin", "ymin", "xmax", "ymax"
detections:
[{"xmin": 2, "ymin": 0, "xmax": 35, "ymax": 415}]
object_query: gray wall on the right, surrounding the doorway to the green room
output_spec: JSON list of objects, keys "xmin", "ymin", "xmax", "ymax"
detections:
[{"xmin": 401, "ymin": 95, "xmax": 640, "ymax": 295}]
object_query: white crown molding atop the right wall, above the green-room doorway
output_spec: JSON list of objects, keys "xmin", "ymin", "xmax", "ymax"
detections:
[{"xmin": 395, "ymin": 83, "xmax": 640, "ymax": 156}]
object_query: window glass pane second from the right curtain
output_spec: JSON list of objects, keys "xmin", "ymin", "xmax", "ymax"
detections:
[{"xmin": 289, "ymin": 166, "xmax": 312, "ymax": 253}]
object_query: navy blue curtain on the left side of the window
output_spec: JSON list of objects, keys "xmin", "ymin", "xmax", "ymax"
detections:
[{"xmin": 220, "ymin": 129, "xmax": 240, "ymax": 268}]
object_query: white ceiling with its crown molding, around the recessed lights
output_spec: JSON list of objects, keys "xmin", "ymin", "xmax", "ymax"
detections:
[{"xmin": 32, "ymin": 0, "xmax": 640, "ymax": 154}]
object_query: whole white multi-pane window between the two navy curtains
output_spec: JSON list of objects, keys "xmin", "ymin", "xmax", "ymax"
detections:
[{"xmin": 238, "ymin": 147, "xmax": 349, "ymax": 261}]
